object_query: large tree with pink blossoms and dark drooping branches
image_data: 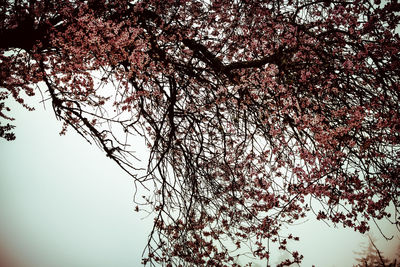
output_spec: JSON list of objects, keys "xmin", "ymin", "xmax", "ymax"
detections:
[{"xmin": 0, "ymin": 0, "xmax": 400, "ymax": 266}]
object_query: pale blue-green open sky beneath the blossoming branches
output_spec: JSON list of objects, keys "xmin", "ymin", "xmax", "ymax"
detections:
[{"xmin": 0, "ymin": 95, "xmax": 400, "ymax": 267}]
